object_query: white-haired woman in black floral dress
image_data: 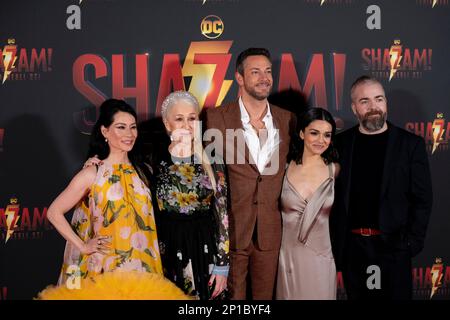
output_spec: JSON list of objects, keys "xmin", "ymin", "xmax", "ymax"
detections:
[{"xmin": 154, "ymin": 91, "xmax": 229, "ymax": 300}]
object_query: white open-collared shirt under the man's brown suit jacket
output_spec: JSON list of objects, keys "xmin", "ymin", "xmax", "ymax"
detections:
[{"xmin": 239, "ymin": 97, "xmax": 279, "ymax": 173}]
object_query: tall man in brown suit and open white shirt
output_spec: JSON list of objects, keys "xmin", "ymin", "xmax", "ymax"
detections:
[{"xmin": 206, "ymin": 48, "xmax": 295, "ymax": 300}]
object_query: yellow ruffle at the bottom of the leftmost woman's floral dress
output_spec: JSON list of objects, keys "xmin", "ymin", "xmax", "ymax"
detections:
[{"xmin": 37, "ymin": 271, "xmax": 192, "ymax": 300}]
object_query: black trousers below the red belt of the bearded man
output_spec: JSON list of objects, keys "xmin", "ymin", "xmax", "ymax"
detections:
[{"xmin": 342, "ymin": 233, "xmax": 412, "ymax": 300}]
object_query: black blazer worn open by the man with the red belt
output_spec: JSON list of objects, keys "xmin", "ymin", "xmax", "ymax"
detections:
[{"xmin": 330, "ymin": 122, "xmax": 433, "ymax": 268}]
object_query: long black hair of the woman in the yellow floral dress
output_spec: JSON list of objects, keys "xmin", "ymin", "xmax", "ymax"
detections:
[{"xmin": 87, "ymin": 99, "xmax": 151, "ymax": 186}]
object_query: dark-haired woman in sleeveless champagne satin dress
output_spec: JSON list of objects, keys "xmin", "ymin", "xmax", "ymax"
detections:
[{"xmin": 276, "ymin": 108, "xmax": 339, "ymax": 300}]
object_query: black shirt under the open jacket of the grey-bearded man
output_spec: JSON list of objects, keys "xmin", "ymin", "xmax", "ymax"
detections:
[{"xmin": 349, "ymin": 129, "xmax": 389, "ymax": 229}]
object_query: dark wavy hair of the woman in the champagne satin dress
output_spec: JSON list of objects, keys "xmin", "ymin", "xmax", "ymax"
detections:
[{"xmin": 288, "ymin": 108, "xmax": 339, "ymax": 164}]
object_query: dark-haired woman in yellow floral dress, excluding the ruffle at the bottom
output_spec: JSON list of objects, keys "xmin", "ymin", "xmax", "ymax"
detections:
[{"xmin": 47, "ymin": 99, "xmax": 162, "ymax": 285}]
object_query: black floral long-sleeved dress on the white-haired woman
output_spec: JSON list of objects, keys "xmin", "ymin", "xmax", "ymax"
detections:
[{"xmin": 155, "ymin": 152, "xmax": 229, "ymax": 300}]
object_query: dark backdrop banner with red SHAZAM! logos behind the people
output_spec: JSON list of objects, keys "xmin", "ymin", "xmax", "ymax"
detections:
[{"xmin": 0, "ymin": 0, "xmax": 450, "ymax": 300}]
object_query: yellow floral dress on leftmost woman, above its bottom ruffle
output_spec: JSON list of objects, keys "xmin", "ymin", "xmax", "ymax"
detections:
[{"xmin": 58, "ymin": 163, "xmax": 162, "ymax": 284}]
